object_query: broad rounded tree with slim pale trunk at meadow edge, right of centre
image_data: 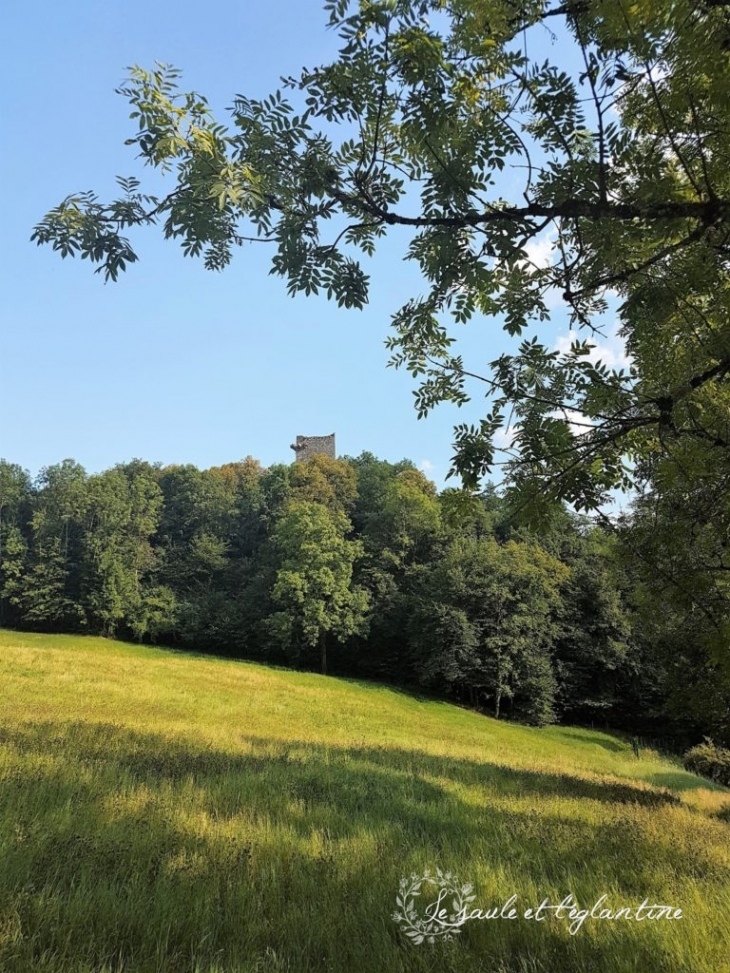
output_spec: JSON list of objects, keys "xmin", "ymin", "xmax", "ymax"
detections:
[{"xmin": 410, "ymin": 536, "xmax": 569, "ymax": 724}]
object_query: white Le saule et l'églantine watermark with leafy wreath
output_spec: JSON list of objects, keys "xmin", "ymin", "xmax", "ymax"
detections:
[{"xmin": 393, "ymin": 868, "xmax": 684, "ymax": 944}]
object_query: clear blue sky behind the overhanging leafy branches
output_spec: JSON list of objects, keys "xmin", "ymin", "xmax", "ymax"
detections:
[{"xmin": 0, "ymin": 0, "xmax": 621, "ymax": 486}]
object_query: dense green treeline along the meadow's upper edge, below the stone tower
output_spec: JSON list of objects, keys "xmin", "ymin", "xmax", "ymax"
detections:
[{"xmin": 0, "ymin": 453, "xmax": 728, "ymax": 746}]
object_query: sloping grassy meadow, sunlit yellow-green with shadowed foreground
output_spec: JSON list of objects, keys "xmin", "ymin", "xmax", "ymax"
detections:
[{"xmin": 0, "ymin": 632, "xmax": 730, "ymax": 973}]
